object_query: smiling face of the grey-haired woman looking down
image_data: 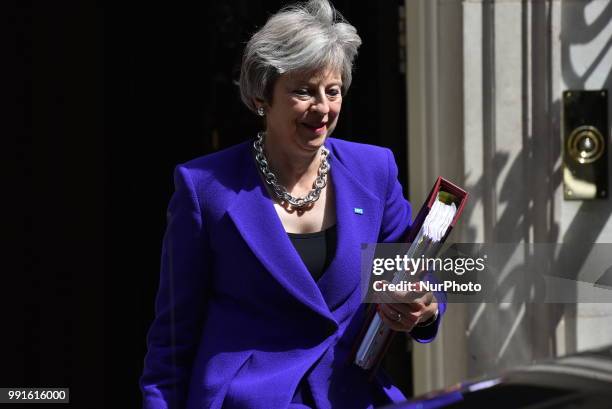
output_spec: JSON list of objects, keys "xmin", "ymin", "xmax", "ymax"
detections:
[{"xmin": 265, "ymin": 70, "xmax": 342, "ymax": 155}]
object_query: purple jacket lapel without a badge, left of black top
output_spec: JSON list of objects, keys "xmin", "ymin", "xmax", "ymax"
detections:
[{"xmin": 228, "ymin": 145, "xmax": 334, "ymax": 320}]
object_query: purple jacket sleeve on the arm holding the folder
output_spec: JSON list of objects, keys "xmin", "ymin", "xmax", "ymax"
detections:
[{"xmin": 379, "ymin": 149, "xmax": 446, "ymax": 343}]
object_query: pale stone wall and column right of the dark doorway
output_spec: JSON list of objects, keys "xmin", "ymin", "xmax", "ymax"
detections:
[{"xmin": 406, "ymin": 0, "xmax": 612, "ymax": 393}]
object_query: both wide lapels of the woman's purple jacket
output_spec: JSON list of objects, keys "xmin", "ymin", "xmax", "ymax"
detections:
[{"xmin": 228, "ymin": 140, "xmax": 382, "ymax": 321}]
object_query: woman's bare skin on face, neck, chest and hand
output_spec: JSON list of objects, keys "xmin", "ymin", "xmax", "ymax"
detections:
[{"xmin": 255, "ymin": 69, "xmax": 438, "ymax": 332}]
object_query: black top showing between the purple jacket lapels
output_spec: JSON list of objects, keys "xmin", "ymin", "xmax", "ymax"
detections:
[{"xmin": 287, "ymin": 225, "xmax": 337, "ymax": 281}]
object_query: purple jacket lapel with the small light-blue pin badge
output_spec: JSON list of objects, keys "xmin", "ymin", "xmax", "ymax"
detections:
[{"xmin": 318, "ymin": 144, "xmax": 382, "ymax": 311}]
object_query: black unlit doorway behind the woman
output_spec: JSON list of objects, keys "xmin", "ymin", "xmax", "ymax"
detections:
[{"xmin": 9, "ymin": 0, "xmax": 411, "ymax": 408}]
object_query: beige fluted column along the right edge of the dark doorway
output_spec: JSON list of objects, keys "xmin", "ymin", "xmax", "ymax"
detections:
[{"xmin": 406, "ymin": 0, "xmax": 467, "ymax": 394}]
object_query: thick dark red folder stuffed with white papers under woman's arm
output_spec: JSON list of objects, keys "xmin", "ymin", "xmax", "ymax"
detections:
[{"xmin": 354, "ymin": 177, "xmax": 468, "ymax": 373}]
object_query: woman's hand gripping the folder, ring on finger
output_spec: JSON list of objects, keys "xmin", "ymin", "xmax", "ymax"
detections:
[{"xmin": 376, "ymin": 278, "xmax": 438, "ymax": 332}]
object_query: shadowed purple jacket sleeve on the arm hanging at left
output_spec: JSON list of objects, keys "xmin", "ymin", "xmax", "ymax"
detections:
[{"xmin": 140, "ymin": 165, "xmax": 211, "ymax": 409}]
